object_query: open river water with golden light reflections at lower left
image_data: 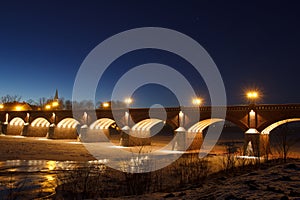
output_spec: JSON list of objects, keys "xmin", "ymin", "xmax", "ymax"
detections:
[{"xmin": 0, "ymin": 159, "xmax": 108, "ymax": 199}]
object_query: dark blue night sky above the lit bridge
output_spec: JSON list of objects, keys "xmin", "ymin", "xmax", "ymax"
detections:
[{"xmin": 0, "ymin": 0, "xmax": 300, "ymax": 106}]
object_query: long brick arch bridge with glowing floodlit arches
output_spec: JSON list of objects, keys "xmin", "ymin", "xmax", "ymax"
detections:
[{"xmin": 0, "ymin": 104, "xmax": 300, "ymax": 156}]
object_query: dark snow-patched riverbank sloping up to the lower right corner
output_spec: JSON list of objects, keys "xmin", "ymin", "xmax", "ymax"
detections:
[{"xmin": 108, "ymin": 160, "xmax": 300, "ymax": 200}]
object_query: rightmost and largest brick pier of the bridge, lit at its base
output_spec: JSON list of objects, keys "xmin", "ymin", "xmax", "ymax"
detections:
[{"xmin": 244, "ymin": 128, "xmax": 270, "ymax": 157}]
